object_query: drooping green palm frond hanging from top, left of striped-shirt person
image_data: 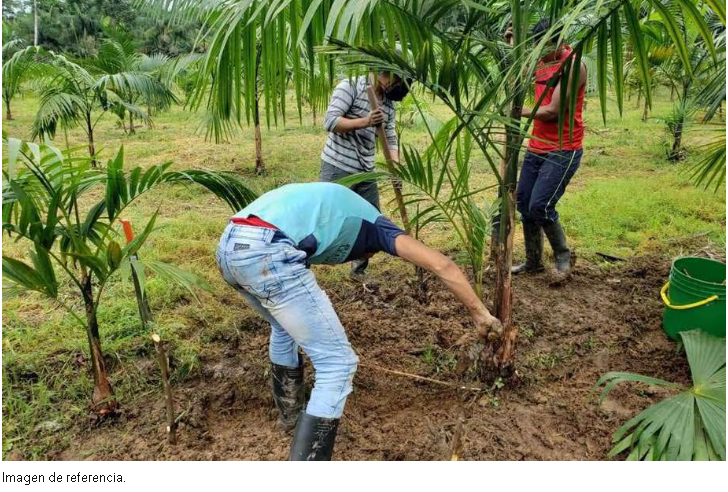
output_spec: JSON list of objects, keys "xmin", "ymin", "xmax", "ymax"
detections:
[{"xmin": 146, "ymin": 0, "xmax": 334, "ymax": 173}]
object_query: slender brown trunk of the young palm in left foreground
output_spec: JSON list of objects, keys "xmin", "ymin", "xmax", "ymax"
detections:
[{"xmin": 83, "ymin": 277, "xmax": 116, "ymax": 417}]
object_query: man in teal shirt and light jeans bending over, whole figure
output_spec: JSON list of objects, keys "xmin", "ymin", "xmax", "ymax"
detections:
[{"xmin": 217, "ymin": 182, "xmax": 502, "ymax": 460}]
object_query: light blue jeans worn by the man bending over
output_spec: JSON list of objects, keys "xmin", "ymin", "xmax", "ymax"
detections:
[{"xmin": 217, "ymin": 223, "xmax": 359, "ymax": 418}]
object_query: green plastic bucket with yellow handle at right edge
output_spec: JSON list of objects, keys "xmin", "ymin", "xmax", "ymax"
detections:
[{"xmin": 660, "ymin": 257, "xmax": 726, "ymax": 340}]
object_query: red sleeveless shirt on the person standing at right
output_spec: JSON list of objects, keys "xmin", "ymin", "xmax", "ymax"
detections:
[{"xmin": 528, "ymin": 46, "xmax": 586, "ymax": 154}]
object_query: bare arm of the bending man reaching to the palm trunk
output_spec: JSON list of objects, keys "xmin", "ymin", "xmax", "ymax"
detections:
[{"xmin": 394, "ymin": 234, "xmax": 503, "ymax": 337}]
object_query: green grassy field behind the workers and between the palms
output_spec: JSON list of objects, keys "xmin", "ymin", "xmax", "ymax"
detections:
[{"xmin": 2, "ymin": 91, "xmax": 726, "ymax": 458}]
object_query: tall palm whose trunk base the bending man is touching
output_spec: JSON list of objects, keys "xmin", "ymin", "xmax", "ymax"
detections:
[{"xmin": 146, "ymin": 0, "xmax": 725, "ymax": 367}]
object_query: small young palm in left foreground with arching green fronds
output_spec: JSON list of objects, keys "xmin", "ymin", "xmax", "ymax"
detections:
[{"xmin": 2, "ymin": 138, "xmax": 255, "ymax": 415}]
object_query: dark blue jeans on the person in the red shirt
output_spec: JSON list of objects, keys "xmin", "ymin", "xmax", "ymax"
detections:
[{"xmin": 516, "ymin": 149, "xmax": 582, "ymax": 225}]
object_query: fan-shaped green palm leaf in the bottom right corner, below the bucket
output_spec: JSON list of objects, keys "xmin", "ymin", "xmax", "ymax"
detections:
[{"xmin": 595, "ymin": 330, "xmax": 726, "ymax": 461}]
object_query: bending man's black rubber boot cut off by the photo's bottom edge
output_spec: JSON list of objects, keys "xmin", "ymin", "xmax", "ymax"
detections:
[{"xmin": 288, "ymin": 412, "xmax": 339, "ymax": 461}]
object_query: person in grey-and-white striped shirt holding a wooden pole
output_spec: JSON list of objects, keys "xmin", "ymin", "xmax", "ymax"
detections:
[{"xmin": 319, "ymin": 72, "xmax": 412, "ymax": 282}]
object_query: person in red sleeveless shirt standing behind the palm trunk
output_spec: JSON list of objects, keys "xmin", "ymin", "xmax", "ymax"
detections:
[{"xmin": 506, "ymin": 19, "xmax": 587, "ymax": 274}]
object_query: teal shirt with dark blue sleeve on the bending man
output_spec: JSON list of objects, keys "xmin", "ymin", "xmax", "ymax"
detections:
[{"xmin": 235, "ymin": 183, "xmax": 405, "ymax": 264}]
